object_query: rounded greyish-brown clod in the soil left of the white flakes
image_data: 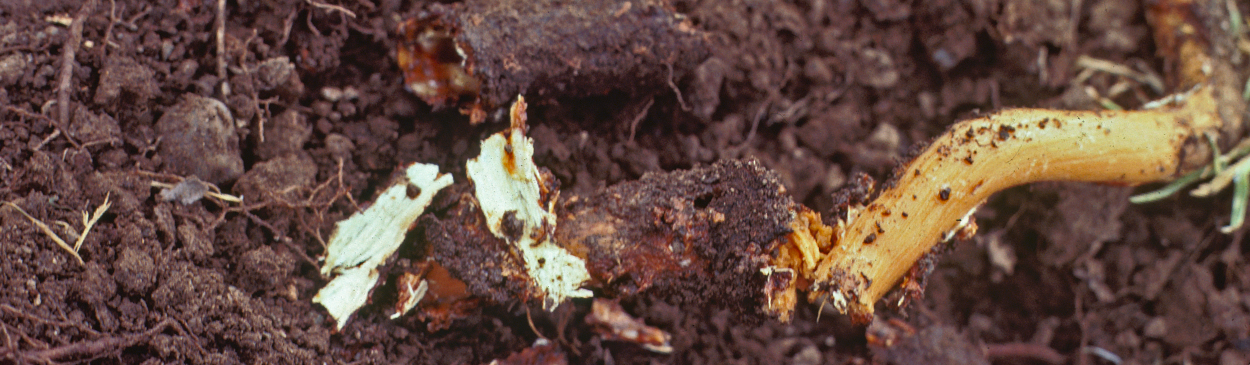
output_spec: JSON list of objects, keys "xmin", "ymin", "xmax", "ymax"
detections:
[{"xmin": 156, "ymin": 94, "xmax": 244, "ymax": 184}]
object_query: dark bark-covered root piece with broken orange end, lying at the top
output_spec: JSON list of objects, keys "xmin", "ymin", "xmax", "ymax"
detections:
[{"xmin": 399, "ymin": 0, "xmax": 708, "ymax": 111}]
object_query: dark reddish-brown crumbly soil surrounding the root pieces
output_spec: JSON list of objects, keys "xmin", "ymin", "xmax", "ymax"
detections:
[{"xmin": 0, "ymin": 0, "xmax": 1250, "ymax": 364}]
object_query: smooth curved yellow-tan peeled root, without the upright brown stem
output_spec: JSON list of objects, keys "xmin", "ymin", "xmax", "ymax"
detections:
[{"xmin": 776, "ymin": 88, "xmax": 1221, "ymax": 321}]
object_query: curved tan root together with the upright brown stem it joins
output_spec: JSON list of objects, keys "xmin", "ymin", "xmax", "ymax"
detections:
[{"xmin": 796, "ymin": 0, "xmax": 1245, "ymax": 321}]
